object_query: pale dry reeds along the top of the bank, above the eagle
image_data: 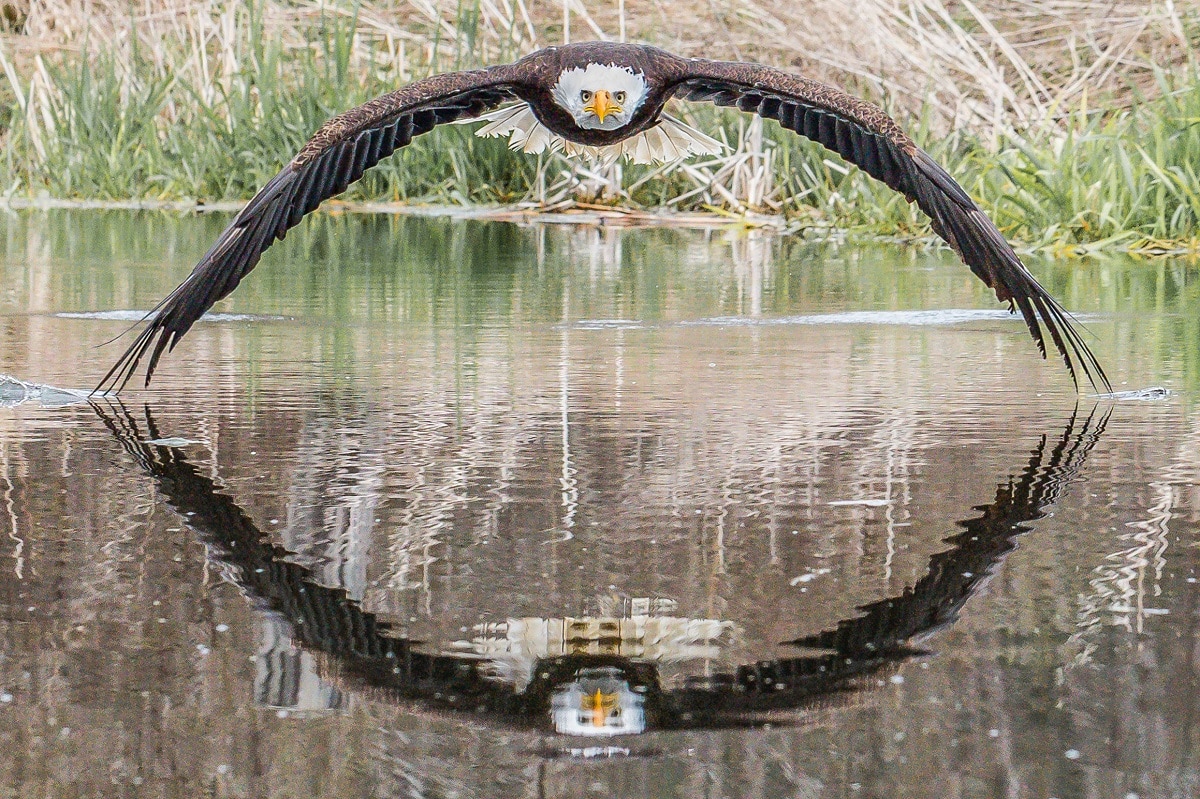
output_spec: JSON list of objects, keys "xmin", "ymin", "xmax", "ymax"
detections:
[{"xmin": 4, "ymin": 0, "xmax": 1200, "ymax": 134}]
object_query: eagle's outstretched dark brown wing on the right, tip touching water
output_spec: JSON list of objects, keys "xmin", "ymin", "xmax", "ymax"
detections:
[{"xmin": 676, "ymin": 60, "xmax": 1112, "ymax": 391}]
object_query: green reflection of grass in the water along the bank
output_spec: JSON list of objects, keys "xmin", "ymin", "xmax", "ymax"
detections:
[{"xmin": 0, "ymin": 211, "xmax": 1200, "ymax": 388}]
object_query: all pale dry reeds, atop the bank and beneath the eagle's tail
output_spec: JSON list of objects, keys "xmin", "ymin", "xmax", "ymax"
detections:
[{"xmin": 0, "ymin": 0, "xmax": 1200, "ymax": 218}]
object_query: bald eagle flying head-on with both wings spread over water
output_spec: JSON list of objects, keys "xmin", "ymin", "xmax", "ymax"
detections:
[{"xmin": 97, "ymin": 42, "xmax": 1111, "ymax": 392}]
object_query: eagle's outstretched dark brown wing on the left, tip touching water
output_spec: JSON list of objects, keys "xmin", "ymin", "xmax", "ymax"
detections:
[{"xmin": 96, "ymin": 67, "xmax": 514, "ymax": 391}]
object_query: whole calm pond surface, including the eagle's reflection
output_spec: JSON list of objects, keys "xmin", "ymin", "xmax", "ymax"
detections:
[{"xmin": 0, "ymin": 211, "xmax": 1200, "ymax": 799}]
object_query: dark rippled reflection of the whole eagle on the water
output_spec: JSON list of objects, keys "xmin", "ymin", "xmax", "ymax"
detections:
[{"xmin": 96, "ymin": 405, "xmax": 1108, "ymax": 737}]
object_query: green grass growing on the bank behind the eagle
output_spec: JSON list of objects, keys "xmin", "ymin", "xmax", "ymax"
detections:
[{"xmin": 0, "ymin": 4, "xmax": 1200, "ymax": 250}]
